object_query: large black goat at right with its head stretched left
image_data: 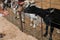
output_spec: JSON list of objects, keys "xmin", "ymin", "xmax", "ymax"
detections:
[{"xmin": 24, "ymin": 5, "xmax": 60, "ymax": 40}]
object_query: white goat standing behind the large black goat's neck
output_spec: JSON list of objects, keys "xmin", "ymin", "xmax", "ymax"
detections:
[{"xmin": 24, "ymin": 0, "xmax": 39, "ymax": 28}]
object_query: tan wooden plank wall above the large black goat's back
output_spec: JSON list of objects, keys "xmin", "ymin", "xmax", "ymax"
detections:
[{"xmin": 36, "ymin": 0, "xmax": 60, "ymax": 9}]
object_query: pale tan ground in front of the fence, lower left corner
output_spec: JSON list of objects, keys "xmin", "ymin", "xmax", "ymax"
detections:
[{"xmin": 0, "ymin": 17, "xmax": 37, "ymax": 40}]
